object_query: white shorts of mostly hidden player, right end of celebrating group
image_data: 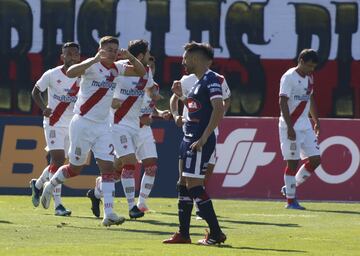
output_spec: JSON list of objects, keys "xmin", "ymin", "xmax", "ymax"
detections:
[{"xmin": 134, "ymin": 126, "xmax": 158, "ymax": 161}]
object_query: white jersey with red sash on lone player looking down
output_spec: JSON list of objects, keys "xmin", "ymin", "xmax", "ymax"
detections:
[{"xmin": 279, "ymin": 67, "xmax": 314, "ymax": 130}]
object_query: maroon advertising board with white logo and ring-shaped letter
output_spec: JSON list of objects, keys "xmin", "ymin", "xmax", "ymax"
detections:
[{"xmin": 208, "ymin": 118, "xmax": 360, "ymax": 201}]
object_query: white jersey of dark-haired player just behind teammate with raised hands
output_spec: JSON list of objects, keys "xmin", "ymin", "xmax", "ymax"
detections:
[{"xmin": 112, "ymin": 61, "xmax": 154, "ymax": 129}]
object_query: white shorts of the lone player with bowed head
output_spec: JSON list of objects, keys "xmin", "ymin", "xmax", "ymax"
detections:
[{"xmin": 279, "ymin": 128, "xmax": 320, "ymax": 160}]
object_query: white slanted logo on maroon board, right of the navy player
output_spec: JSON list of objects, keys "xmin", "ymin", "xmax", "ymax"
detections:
[{"xmin": 214, "ymin": 129, "xmax": 276, "ymax": 188}]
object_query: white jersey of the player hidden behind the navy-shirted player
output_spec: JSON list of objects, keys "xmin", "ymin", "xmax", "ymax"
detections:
[{"xmin": 180, "ymin": 72, "xmax": 231, "ymax": 135}]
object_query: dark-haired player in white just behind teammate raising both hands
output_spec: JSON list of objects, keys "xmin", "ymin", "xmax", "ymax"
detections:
[{"xmin": 112, "ymin": 40, "xmax": 157, "ymax": 218}]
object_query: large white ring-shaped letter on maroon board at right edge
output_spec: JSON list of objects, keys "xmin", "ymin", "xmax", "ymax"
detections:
[{"xmin": 315, "ymin": 136, "xmax": 360, "ymax": 184}]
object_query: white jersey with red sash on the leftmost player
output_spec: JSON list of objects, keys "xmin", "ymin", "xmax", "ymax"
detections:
[{"xmin": 35, "ymin": 66, "xmax": 79, "ymax": 127}]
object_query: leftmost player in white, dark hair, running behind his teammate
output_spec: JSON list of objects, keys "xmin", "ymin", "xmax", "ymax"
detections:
[{"xmin": 30, "ymin": 42, "xmax": 80, "ymax": 216}]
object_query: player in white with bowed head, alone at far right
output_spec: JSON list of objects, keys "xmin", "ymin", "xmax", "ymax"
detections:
[{"xmin": 279, "ymin": 49, "xmax": 320, "ymax": 210}]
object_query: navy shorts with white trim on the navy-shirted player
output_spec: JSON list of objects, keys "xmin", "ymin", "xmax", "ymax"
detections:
[{"xmin": 179, "ymin": 134, "xmax": 216, "ymax": 178}]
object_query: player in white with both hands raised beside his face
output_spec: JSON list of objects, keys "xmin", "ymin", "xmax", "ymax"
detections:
[{"xmin": 41, "ymin": 36, "xmax": 145, "ymax": 226}]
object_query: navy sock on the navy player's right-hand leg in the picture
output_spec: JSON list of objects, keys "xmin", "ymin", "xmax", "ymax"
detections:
[{"xmin": 189, "ymin": 186, "xmax": 221, "ymax": 237}]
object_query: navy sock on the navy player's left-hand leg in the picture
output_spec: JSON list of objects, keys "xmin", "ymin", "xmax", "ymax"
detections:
[{"xmin": 178, "ymin": 186, "xmax": 194, "ymax": 238}]
